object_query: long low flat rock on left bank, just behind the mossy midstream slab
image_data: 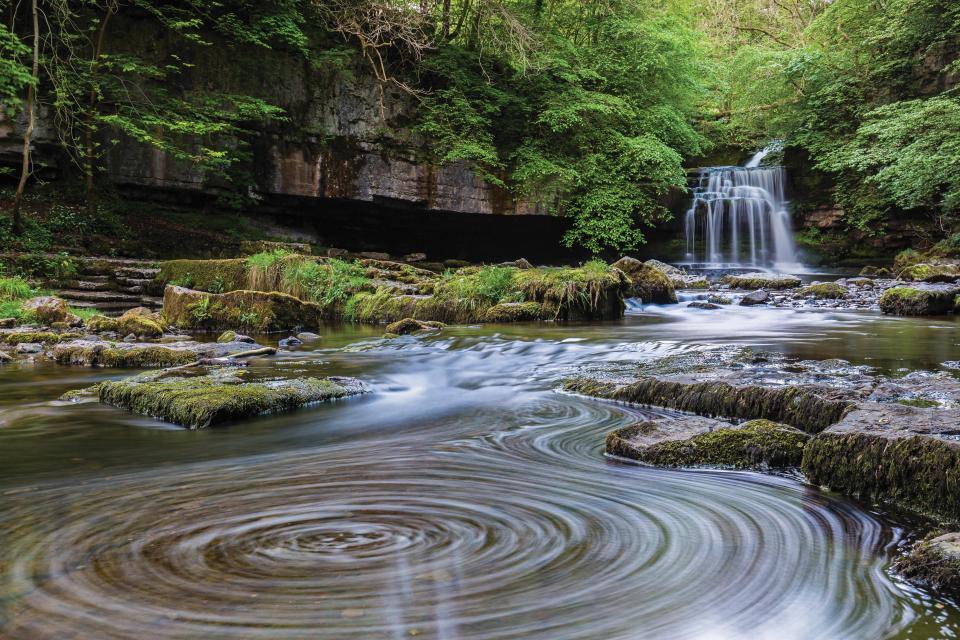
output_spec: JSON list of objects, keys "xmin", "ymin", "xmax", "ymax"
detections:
[{"xmin": 53, "ymin": 340, "xmax": 272, "ymax": 368}]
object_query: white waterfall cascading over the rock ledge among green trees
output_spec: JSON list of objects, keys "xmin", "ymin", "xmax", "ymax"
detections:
[{"xmin": 684, "ymin": 148, "xmax": 799, "ymax": 269}]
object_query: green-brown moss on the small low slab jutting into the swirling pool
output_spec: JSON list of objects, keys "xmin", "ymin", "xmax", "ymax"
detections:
[{"xmin": 606, "ymin": 420, "xmax": 810, "ymax": 469}]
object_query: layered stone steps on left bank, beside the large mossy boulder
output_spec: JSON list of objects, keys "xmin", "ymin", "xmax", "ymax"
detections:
[{"xmin": 48, "ymin": 258, "xmax": 163, "ymax": 315}]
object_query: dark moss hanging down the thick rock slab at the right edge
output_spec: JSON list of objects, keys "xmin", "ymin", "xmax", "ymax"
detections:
[{"xmin": 802, "ymin": 432, "xmax": 960, "ymax": 519}]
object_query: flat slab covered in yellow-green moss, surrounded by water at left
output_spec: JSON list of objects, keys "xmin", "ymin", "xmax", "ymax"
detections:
[{"xmin": 97, "ymin": 367, "xmax": 366, "ymax": 429}]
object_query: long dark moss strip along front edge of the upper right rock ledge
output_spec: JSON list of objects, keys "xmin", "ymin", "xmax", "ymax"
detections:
[{"xmin": 564, "ymin": 378, "xmax": 853, "ymax": 433}]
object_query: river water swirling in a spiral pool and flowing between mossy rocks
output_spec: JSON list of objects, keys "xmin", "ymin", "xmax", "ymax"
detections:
[{"xmin": 0, "ymin": 307, "xmax": 960, "ymax": 640}]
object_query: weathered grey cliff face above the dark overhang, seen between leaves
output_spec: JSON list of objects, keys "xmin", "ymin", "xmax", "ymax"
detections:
[{"xmin": 0, "ymin": 17, "xmax": 547, "ymax": 219}]
